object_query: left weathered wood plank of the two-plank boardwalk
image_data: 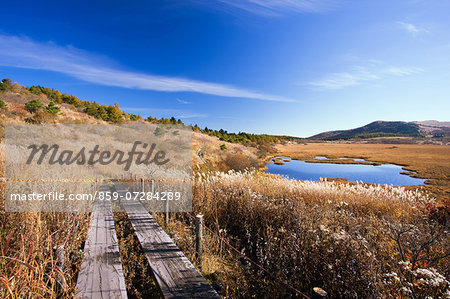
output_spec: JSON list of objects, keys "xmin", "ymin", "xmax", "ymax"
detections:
[{"xmin": 75, "ymin": 183, "xmax": 127, "ymax": 298}]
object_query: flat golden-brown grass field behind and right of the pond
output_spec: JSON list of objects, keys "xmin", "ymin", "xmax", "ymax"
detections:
[{"xmin": 277, "ymin": 142, "xmax": 450, "ymax": 200}]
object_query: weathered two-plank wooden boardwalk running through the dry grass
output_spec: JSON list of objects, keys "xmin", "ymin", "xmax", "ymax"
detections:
[{"xmin": 75, "ymin": 182, "xmax": 220, "ymax": 299}]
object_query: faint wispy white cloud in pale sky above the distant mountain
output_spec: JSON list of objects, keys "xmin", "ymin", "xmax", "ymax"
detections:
[{"xmin": 308, "ymin": 66, "xmax": 423, "ymax": 89}]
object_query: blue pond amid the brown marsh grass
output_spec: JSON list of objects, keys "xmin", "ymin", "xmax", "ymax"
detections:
[{"xmin": 266, "ymin": 157, "xmax": 425, "ymax": 186}]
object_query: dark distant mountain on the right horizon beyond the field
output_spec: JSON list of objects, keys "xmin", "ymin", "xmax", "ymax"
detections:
[{"xmin": 309, "ymin": 120, "xmax": 450, "ymax": 140}]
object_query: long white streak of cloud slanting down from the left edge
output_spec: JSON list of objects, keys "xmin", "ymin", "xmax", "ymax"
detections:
[{"xmin": 0, "ymin": 35, "xmax": 295, "ymax": 102}]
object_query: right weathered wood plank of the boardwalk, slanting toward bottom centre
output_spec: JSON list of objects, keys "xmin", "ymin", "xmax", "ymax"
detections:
[{"xmin": 115, "ymin": 183, "xmax": 220, "ymax": 298}]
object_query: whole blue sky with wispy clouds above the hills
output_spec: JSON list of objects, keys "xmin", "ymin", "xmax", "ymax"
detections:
[{"xmin": 0, "ymin": 0, "xmax": 450, "ymax": 137}]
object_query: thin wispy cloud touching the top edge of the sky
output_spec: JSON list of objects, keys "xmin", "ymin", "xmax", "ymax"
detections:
[{"xmin": 219, "ymin": 0, "xmax": 337, "ymax": 17}]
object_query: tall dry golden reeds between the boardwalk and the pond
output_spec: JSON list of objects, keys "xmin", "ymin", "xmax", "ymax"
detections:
[{"xmin": 188, "ymin": 172, "xmax": 449, "ymax": 298}]
